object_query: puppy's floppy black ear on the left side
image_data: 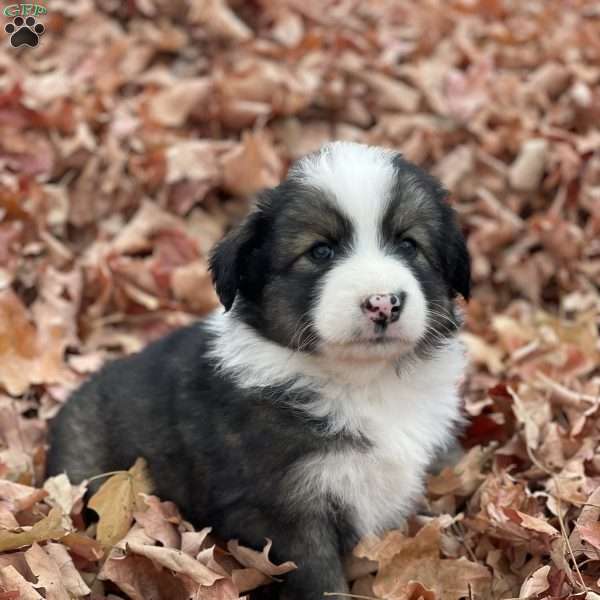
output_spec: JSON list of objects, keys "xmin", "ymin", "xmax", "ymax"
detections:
[{"xmin": 209, "ymin": 206, "xmax": 266, "ymax": 311}]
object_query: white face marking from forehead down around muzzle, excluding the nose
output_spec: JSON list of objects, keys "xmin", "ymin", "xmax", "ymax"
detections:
[{"xmin": 290, "ymin": 142, "xmax": 426, "ymax": 353}]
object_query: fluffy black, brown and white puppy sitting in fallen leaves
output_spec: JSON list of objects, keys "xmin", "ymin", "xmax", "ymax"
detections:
[{"xmin": 48, "ymin": 142, "xmax": 470, "ymax": 600}]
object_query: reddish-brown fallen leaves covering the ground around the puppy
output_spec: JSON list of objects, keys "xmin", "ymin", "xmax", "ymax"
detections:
[{"xmin": 0, "ymin": 0, "xmax": 600, "ymax": 600}]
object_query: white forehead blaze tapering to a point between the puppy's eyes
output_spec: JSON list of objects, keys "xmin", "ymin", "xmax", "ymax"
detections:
[{"xmin": 290, "ymin": 142, "xmax": 396, "ymax": 248}]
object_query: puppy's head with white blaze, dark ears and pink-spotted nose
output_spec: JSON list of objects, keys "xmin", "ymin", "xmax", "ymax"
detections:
[{"xmin": 211, "ymin": 142, "xmax": 470, "ymax": 360}]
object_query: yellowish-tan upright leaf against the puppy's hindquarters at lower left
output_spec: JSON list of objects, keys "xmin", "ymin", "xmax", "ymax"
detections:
[{"xmin": 88, "ymin": 458, "xmax": 151, "ymax": 546}]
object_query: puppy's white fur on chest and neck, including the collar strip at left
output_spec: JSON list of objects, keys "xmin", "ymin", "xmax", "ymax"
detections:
[{"xmin": 212, "ymin": 317, "xmax": 465, "ymax": 535}]
